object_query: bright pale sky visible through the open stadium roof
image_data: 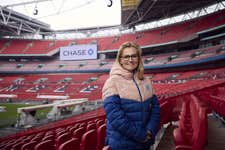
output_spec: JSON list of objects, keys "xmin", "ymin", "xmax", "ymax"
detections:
[{"xmin": 0, "ymin": 0, "xmax": 121, "ymax": 30}]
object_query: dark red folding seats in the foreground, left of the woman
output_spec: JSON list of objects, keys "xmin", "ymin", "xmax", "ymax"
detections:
[{"xmin": 0, "ymin": 119, "xmax": 106, "ymax": 150}]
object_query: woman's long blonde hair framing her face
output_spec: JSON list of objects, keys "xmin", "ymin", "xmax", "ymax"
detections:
[{"xmin": 116, "ymin": 42, "xmax": 144, "ymax": 80}]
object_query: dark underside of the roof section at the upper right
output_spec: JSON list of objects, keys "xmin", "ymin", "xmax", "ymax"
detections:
[{"xmin": 122, "ymin": 0, "xmax": 224, "ymax": 26}]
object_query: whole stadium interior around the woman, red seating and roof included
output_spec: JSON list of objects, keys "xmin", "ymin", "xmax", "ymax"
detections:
[{"xmin": 0, "ymin": 0, "xmax": 225, "ymax": 150}]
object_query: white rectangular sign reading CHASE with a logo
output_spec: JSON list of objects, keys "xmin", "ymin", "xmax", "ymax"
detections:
[{"xmin": 60, "ymin": 44, "xmax": 97, "ymax": 60}]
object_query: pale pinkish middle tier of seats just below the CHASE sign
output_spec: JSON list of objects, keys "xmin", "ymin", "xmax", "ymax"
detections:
[{"xmin": 0, "ymin": 44, "xmax": 225, "ymax": 72}]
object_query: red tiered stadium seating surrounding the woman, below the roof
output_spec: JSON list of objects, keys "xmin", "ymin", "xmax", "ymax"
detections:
[{"xmin": 0, "ymin": 1, "xmax": 225, "ymax": 150}]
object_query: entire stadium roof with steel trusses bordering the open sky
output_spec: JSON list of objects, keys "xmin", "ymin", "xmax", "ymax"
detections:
[{"xmin": 0, "ymin": 0, "xmax": 224, "ymax": 37}]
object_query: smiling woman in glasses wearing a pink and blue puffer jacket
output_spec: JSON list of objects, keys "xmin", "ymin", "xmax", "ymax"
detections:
[{"xmin": 102, "ymin": 42, "xmax": 160, "ymax": 150}]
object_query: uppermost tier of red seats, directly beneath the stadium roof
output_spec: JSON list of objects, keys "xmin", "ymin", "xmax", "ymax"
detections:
[{"xmin": 0, "ymin": 8, "xmax": 225, "ymax": 54}]
